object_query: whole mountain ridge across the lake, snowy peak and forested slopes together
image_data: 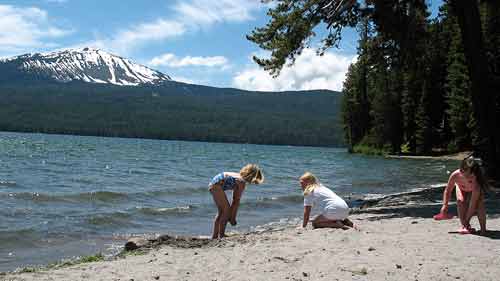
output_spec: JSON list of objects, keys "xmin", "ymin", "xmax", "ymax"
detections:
[{"xmin": 0, "ymin": 48, "xmax": 343, "ymax": 146}]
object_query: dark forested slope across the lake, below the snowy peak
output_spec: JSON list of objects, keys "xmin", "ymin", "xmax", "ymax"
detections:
[{"xmin": 0, "ymin": 79, "xmax": 343, "ymax": 146}]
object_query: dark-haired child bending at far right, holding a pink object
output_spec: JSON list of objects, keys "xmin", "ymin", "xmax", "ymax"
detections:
[{"xmin": 441, "ymin": 157, "xmax": 487, "ymax": 235}]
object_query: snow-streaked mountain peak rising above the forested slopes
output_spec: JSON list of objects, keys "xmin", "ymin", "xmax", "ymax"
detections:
[{"xmin": 0, "ymin": 48, "xmax": 172, "ymax": 86}]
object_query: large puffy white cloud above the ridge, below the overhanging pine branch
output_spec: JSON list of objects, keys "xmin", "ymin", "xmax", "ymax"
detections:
[{"xmin": 233, "ymin": 49, "xmax": 356, "ymax": 91}]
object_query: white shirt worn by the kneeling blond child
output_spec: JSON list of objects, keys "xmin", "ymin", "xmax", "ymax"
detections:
[{"xmin": 304, "ymin": 184, "xmax": 349, "ymax": 214}]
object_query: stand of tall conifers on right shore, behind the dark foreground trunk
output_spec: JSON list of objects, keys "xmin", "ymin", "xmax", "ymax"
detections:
[{"xmin": 342, "ymin": 1, "xmax": 500, "ymax": 154}]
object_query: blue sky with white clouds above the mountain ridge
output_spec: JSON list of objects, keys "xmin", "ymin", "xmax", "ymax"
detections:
[{"xmin": 0, "ymin": 0, "xmax": 441, "ymax": 91}]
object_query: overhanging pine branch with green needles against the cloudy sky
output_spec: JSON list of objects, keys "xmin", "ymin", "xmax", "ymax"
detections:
[{"xmin": 247, "ymin": 0, "xmax": 359, "ymax": 75}]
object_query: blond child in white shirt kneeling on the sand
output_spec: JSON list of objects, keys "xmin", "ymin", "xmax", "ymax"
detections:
[{"xmin": 300, "ymin": 172, "xmax": 357, "ymax": 229}]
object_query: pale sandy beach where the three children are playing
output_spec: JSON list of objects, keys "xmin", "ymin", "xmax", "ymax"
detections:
[{"xmin": 0, "ymin": 188, "xmax": 500, "ymax": 281}]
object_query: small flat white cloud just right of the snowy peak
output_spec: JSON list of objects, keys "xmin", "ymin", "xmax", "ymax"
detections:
[{"xmin": 149, "ymin": 54, "xmax": 228, "ymax": 68}]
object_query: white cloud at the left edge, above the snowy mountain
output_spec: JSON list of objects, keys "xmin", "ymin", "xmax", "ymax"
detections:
[{"xmin": 0, "ymin": 5, "xmax": 72, "ymax": 53}]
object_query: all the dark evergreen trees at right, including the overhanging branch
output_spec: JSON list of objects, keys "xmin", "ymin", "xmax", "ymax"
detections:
[{"xmin": 247, "ymin": 0, "xmax": 500, "ymax": 177}]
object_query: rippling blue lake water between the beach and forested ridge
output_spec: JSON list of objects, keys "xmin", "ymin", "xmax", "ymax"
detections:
[{"xmin": 0, "ymin": 132, "xmax": 457, "ymax": 271}]
